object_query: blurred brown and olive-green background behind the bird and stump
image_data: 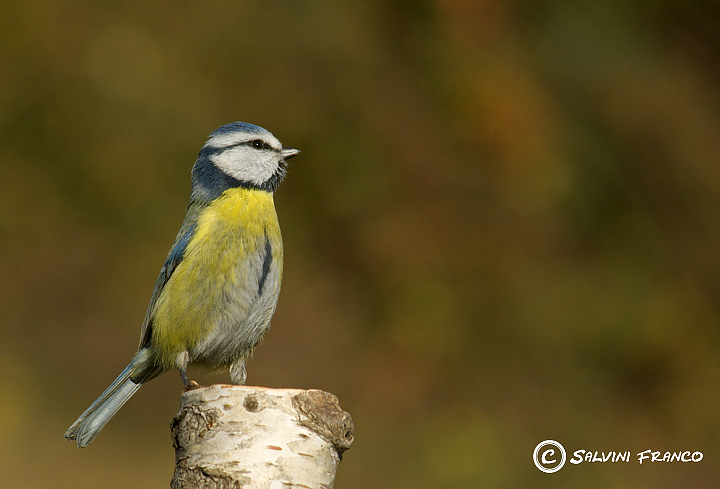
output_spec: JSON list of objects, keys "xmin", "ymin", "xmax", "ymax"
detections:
[{"xmin": 0, "ymin": 0, "xmax": 720, "ymax": 489}]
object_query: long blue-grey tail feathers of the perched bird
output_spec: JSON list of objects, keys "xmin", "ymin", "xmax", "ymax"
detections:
[{"xmin": 65, "ymin": 363, "xmax": 142, "ymax": 447}]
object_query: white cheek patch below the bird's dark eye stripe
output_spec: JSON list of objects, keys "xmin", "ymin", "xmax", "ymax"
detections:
[{"xmin": 210, "ymin": 146, "xmax": 278, "ymax": 186}]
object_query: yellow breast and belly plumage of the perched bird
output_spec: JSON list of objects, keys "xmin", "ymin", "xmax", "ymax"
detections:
[{"xmin": 152, "ymin": 188, "xmax": 283, "ymax": 368}]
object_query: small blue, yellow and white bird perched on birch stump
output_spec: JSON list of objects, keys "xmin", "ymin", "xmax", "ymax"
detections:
[{"xmin": 65, "ymin": 122, "xmax": 300, "ymax": 447}]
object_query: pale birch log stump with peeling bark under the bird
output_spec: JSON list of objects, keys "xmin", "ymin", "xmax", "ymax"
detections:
[{"xmin": 170, "ymin": 385, "xmax": 354, "ymax": 489}]
